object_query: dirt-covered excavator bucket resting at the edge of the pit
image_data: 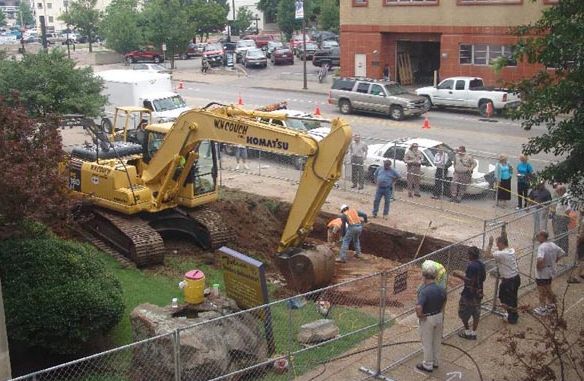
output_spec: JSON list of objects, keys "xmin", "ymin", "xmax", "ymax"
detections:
[{"xmin": 276, "ymin": 245, "xmax": 335, "ymax": 293}]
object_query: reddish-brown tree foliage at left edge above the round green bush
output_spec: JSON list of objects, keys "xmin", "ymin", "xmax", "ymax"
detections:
[{"xmin": 0, "ymin": 98, "xmax": 69, "ymax": 223}]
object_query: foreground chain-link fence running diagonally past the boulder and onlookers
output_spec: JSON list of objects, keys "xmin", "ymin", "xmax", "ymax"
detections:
[{"xmin": 14, "ymin": 201, "xmax": 580, "ymax": 381}]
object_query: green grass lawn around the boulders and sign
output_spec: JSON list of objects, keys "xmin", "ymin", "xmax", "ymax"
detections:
[{"xmin": 98, "ymin": 249, "xmax": 386, "ymax": 380}]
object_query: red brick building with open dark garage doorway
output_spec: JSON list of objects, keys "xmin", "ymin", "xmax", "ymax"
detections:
[{"xmin": 340, "ymin": 0, "xmax": 557, "ymax": 84}]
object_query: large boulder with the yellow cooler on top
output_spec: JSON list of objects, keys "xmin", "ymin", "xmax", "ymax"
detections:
[{"xmin": 130, "ymin": 298, "xmax": 268, "ymax": 381}]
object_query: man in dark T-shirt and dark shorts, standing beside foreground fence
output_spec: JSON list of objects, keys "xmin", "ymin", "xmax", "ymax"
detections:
[{"xmin": 452, "ymin": 246, "xmax": 487, "ymax": 340}]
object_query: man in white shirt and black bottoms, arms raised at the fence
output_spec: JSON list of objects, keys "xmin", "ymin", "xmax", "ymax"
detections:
[{"xmin": 485, "ymin": 233, "xmax": 521, "ymax": 324}]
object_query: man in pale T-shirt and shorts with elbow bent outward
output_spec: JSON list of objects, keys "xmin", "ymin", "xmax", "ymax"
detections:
[{"xmin": 533, "ymin": 231, "xmax": 566, "ymax": 316}]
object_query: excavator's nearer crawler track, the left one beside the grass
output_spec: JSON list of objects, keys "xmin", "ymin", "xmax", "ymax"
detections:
[{"xmin": 83, "ymin": 209, "xmax": 165, "ymax": 267}]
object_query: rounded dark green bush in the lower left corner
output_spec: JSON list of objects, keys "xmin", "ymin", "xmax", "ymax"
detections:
[{"xmin": 0, "ymin": 238, "xmax": 124, "ymax": 354}]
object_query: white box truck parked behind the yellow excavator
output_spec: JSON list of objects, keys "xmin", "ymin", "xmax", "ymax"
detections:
[{"xmin": 95, "ymin": 70, "xmax": 190, "ymax": 131}]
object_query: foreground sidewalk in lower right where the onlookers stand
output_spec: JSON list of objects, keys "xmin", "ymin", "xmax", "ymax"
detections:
[{"xmin": 298, "ymin": 268, "xmax": 584, "ymax": 381}]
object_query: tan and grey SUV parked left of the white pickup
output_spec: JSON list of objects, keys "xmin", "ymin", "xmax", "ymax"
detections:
[{"xmin": 328, "ymin": 77, "xmax": 429, "ymax": 120}]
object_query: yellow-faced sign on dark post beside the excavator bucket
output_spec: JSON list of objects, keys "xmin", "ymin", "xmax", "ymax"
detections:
[{"xmin": 219, "ymin": 246, "xmax": 276, "ymax": 356}]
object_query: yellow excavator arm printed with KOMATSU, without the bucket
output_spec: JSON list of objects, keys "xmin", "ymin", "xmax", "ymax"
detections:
[{"xmin": 142, "ymin": 106, "xmax": 351, "ymax": 252}]
